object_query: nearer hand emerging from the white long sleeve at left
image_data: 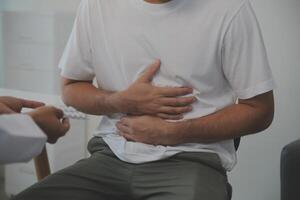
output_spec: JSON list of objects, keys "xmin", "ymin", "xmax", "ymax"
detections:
[{"xmin": 27, "ymin": 106, "xmax": 70, "ymax": 144}]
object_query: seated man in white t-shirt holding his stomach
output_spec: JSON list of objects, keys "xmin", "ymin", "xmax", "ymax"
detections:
[{"xmin": 16, "ymin": 0, "xmax": 274, "ymax": 200}]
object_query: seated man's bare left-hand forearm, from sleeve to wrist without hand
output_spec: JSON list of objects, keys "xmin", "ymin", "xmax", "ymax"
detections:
[{"xmin": 62, "ymin": 82, "xmax": 121, "ymax": 115}]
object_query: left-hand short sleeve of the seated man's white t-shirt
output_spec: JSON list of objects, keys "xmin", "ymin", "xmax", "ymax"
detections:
[{"xmin": 59, "ymin": 0, "xmax": 95, "ymax": 81}]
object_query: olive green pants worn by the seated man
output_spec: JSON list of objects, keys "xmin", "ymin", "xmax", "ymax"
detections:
[{"xmin": 13, "ymin": 138, "xmax": 229, "ymax": 200}]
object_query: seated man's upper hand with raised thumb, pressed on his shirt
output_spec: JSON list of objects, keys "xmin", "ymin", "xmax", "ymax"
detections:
[{"xmin": 115, "ymin": 60, "xmax": 196, "ymax": 120}]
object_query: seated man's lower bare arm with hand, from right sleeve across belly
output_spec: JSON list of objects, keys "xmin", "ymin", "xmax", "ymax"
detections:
[{"xmin": 117, "ymin": 92, "xmax": 274, "ymax": 145}]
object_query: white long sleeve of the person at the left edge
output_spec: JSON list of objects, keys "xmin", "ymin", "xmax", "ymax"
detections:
[{"xmin": 0, "ymin": 114, "xmax": 47, "ymax": 164}]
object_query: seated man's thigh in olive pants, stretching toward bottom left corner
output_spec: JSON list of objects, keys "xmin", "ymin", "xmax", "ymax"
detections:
[{"xmin": 13, "ymin": 152, "xmax": 130, "ymax": 200}]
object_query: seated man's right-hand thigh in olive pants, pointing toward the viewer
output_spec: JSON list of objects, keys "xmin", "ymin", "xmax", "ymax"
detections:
[{"xmin": 132, "ymin": 153, "xmax": 229, "ymax": 200}]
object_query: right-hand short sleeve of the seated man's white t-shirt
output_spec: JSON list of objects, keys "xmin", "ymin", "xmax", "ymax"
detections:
[{"xmin": 222, "ymin": 1, "xmax": 275, "ymax": 99}]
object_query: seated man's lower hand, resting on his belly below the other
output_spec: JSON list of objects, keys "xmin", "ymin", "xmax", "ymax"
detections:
[{"xmin": 116, "ymin": 116, "xmax": 180, "ymax": 145}]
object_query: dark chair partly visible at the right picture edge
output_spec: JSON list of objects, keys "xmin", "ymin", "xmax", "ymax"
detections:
[{"xmin": 280, "ymin": 139, "xmax": 300, "ymax": 200}]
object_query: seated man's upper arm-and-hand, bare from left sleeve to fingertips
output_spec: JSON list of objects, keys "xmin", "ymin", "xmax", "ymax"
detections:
[{"xmin": 62, "ymin": 61, "xmax": 196, "ymax": 119}]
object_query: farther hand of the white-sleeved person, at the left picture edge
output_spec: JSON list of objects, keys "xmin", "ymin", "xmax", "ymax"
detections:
[{"xmin": 0, "ymin": 96, "xmax": 45, "ymax": 114}]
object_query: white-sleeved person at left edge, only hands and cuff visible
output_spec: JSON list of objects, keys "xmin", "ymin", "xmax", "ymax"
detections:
[{"xmin": 0, "ymin": 97, "xmax": 70, "ymax": 164}]
